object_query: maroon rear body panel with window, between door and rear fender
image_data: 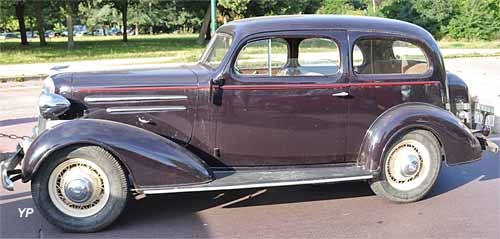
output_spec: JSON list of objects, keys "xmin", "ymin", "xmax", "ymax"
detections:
[{"xmin": 346, "ymin": 32, "xmax": 442, "ymax": 162}]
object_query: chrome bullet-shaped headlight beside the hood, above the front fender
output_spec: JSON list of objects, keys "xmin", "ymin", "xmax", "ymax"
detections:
[{"xmin": 38, "ymin": 90, "xmax": 71, "ymax": 119}]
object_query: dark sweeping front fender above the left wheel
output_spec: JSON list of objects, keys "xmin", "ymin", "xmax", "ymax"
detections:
[{"xmin": 22, "ymin": 119, "xmax": 212, "ymax": 187}]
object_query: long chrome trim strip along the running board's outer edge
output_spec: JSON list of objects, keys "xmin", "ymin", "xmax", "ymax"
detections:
[{"xmin": 132, "ymin": 175, "xmax": 373, "ymax": 194}]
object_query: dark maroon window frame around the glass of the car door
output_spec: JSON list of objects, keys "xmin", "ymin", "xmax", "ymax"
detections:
[{"xmin": 228, "ymin": 29, "xmax": 348, "ymax": 84}]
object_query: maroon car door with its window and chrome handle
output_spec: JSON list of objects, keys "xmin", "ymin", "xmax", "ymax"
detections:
[{"xmin": 215, "ymin": 31, "xmax": 349, "ymax": 167}]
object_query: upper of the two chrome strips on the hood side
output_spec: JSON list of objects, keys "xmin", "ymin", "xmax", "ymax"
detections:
[{"xmin": 84, "ymin": 95, "xmax": 187, "ymax": 104}]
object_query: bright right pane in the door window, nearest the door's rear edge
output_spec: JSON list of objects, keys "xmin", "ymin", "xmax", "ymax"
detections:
[{"xmin": 298, "ymin": 38, "xmax": 340, "ymax": 76}]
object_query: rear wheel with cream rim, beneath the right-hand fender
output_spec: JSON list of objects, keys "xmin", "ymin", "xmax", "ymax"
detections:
[{"xmin": 370, "ymin": 130, "xmax": 441, "ymax": 203}]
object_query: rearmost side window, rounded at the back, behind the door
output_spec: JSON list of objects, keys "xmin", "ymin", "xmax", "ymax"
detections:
[{"xmin": 352, "ymin": 39, "xmax": 429, "ymax": 75}]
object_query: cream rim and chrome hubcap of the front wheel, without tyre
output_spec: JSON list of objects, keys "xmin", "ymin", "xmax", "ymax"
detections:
[{"xmin": 49, "ymin": 158, "xmax": 110, "ymax": 217}]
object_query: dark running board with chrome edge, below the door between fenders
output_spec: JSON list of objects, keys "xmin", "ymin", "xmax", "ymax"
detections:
[{"xmin": 134, "ymin": 167, "xmax": 373, "ymax": 194}]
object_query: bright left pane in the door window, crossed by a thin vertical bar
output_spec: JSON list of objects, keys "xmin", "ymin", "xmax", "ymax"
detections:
[{"xmin": 234, "ymin": 38, "xmax": 288, "ymax": 76}]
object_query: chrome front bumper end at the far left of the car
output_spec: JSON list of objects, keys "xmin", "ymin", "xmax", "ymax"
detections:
[{"xmin": 0, "ymin": 145, "xmax": 24, "ymax": 191}]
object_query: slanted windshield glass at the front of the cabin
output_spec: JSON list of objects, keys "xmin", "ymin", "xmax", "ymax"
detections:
[{"xmin": 201, "ymin": 33, "xmax": 232, "ymax": 68}]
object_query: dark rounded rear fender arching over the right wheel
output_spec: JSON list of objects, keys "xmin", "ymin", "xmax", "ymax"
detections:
[{"xmin": 358, "ymin": 103, "xmax": 481, "ymax": 171}]
